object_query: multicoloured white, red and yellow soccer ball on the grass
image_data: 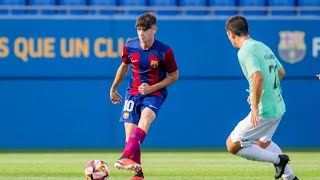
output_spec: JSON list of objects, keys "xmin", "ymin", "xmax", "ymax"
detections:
[{"xmin": 84, "ymin": 160, "xmax": 109, "ymax": 180}]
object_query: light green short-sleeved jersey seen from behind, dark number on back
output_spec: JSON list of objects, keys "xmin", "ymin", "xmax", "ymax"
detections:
[{"xmin": 238, "ymin": 38, "xmax": 286, "ymax": 118}]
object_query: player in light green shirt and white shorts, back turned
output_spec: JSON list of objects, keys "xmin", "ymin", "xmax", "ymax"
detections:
[{"xmin": 226, "ymin": 16, "xmax": 298, "ymax": 180}]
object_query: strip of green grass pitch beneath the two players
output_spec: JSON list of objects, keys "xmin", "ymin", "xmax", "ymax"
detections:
[{"xmin": 0, "ymin": 149, "xmax": 320, "ymax": 180}]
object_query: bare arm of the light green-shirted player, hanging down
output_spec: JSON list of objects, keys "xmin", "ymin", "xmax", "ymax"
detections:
[{"xmin": 251, "ymin": 71, "xmax": 263, "ymax": 128}]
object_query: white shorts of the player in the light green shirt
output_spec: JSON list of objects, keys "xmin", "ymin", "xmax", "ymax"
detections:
[{"xmin": 230, "ymin": 113, "xmax": 282, "ymax": 147}]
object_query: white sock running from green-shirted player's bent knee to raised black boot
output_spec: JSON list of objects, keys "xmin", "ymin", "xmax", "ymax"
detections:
[{"xmin": 237, "ymin": 144, "xmax": 280, "ymax": 164}]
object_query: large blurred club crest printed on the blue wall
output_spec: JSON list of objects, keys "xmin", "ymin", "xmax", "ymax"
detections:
[{"xmin": 278, "ymin": 31, "xmax": 306, "ymax": 64}]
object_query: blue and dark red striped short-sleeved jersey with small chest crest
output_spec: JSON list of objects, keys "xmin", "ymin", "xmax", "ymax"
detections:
[{"xmin": 122, "ymin": 38, "xmax": 178, "ymax": 96}]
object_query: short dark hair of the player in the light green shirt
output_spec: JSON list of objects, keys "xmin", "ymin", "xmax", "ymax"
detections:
[{"xmin": 226, "ymin": 16, "xmax": 249, "ymax": 36}]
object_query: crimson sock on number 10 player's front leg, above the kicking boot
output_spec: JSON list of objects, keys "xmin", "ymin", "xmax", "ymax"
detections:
[{"xmin": 122, "ymin": 127, "xmax": 146, "ymax": 159}]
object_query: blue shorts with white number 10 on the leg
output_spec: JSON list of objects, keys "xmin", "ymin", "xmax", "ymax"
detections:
[{"xmin": 120, "ymin": 93, "xmax": 165, "ymax": 125}]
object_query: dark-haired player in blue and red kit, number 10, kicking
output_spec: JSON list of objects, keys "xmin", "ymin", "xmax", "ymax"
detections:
[{"xmin": 110, "ymin": 13, "xmax": 179, "ymax": 180}]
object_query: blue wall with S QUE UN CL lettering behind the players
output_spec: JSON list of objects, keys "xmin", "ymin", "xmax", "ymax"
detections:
[{"xmin": 0, "ymin": 19, "xmax": 320, "ymax": 148}]
